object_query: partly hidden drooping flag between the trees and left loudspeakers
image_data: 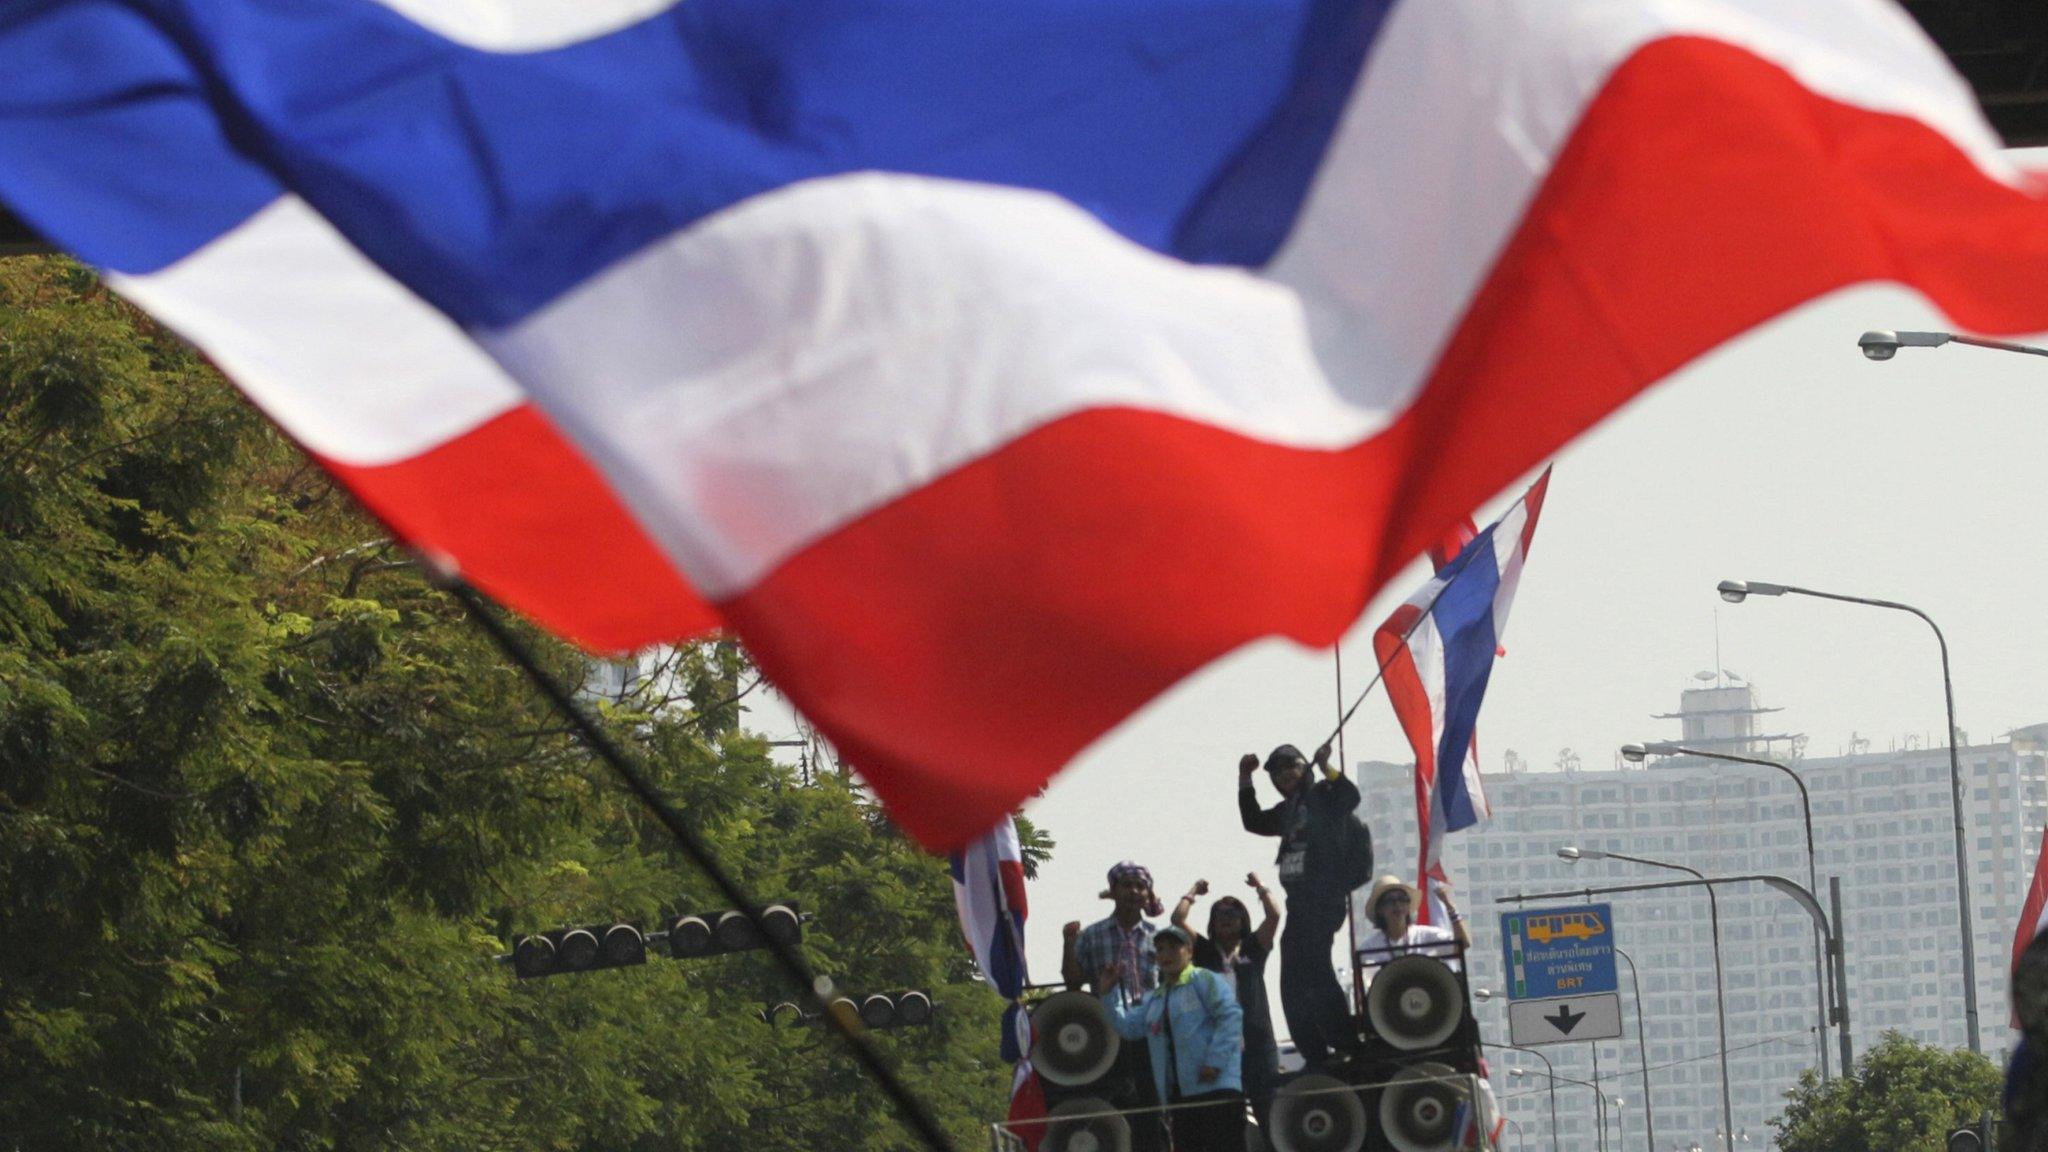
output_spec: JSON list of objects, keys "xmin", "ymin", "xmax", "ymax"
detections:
[{"xmin": 950, "ymin": 816, "xmax": 1044, "ymax": 1148}]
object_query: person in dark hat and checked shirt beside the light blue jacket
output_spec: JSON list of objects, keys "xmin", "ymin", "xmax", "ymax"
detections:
[{"xmin": 1059, "ymin": 861, "xmax": 1167, "ymax": 1152}]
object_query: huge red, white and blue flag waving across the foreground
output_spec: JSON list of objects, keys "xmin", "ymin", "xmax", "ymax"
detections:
[{"xmin": 0, "ymin": 0, "xmax": 2048, "ymax": 849}]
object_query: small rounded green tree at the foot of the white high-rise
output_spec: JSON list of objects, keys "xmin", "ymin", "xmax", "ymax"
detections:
[{"xmin": 1772, "ymin": 1031, "xmax": 2001, "ymax": 1152}]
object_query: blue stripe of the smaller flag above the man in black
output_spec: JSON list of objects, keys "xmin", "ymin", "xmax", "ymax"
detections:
[{"xmin": 1430, "ymin": 525, "xmax": 1501, "ymax": 832}]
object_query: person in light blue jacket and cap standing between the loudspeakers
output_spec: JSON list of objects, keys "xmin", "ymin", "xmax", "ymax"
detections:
[{"xmin": 1096, "ymin": 927, "xmax": 1245, "ymax": 1152}]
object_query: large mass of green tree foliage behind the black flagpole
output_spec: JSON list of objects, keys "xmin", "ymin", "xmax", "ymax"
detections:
[{"xmin": 0, "ymin": 260, "xmax": 1024, "ymax": 1152}]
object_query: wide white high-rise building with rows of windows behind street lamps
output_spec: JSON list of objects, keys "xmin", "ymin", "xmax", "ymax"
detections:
[{"xmin": 1358, "ymin": 685, "xmax": 2048, "ymax": 1152}]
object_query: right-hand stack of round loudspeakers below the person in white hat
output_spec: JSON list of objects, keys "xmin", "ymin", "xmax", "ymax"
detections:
[{"xmin": 1268, "ymin": 945, "xmax": 1493, "ymax": 1152}]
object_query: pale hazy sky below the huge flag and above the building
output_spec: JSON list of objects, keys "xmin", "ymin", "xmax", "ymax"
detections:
[{"xmin": 754, "ymin": 161, "xmax": 2048, "ymax": 980}]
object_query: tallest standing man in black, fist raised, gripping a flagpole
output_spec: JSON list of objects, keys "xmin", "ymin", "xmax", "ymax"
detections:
[{"xmin": 1237, "ymin": 744, "xmax": 1372, "ymax": 1066}]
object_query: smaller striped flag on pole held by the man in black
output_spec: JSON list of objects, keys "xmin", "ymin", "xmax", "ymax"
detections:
[{"xmin": 1372, "ymin": 467, "xmax": 1550, "ymax": 922}]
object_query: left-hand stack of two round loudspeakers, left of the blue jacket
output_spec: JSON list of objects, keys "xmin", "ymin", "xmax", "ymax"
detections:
[{"xmin": 1030, "ymin": 992, "xmax": 1137, "ymax": 1152}]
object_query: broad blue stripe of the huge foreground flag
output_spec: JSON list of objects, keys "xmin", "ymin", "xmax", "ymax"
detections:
[{"xmin": 0, "ymin": 0, "xmax": 1391, "ymax": 317}]
